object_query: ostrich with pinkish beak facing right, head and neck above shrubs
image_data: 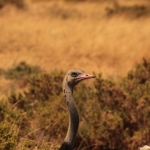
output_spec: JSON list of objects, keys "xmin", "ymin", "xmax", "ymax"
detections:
[{"xmin": 59, "ymin": 69, "xmax": 95, "ymax": 150}]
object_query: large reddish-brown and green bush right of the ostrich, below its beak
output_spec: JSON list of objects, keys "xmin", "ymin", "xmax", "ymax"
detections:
[{"xmin": 94, "ymin": 60, "xmax": 150, "ymax": 149}]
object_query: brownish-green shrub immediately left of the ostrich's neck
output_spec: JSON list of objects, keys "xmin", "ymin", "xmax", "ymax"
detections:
[{"xmin": 9, "ymin": 72, "xmax": 67, "ymax": 148}]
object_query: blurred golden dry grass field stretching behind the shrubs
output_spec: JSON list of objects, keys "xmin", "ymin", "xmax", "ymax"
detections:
[{"xmin": 0, "ymin": 1, "xmax": 150, "ymax": 79}]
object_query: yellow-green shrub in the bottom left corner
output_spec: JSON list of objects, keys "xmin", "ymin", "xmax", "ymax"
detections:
[{"xmin": 0, "ymin": 100, "xmax": 19, "ymax": 150}]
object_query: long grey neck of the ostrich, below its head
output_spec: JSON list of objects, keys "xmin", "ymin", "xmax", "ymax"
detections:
[{"xmin": 63, "ymin": 83, "xmax": 79, "ymax": 146}]
